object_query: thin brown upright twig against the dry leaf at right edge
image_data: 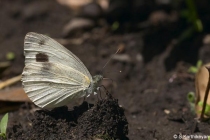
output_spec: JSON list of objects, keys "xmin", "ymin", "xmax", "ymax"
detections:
[{"xmin": 200, "ymin": 66, "xmax": 210, "ymax": 121}]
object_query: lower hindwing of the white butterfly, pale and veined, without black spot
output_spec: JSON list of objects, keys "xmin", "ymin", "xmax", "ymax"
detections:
[{"xmin": 22, "ymin": 62, "xmax": 90, "ymax": 108}]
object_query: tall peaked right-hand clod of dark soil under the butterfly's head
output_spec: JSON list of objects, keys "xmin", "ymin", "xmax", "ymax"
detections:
[{"xmin": 74, "ymin": 94, "xmax": 128, "ymax": 140}]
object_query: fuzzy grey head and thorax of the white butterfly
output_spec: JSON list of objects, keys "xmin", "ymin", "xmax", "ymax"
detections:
[{"xmin": 87, "ymin": 75, "xmax": 103, "ymax": 94}]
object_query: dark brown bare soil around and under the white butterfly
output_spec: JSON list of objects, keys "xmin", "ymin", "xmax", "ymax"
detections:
[{"xmin": 0, "ymin": 0, "xmax": 210, "ymax": 140}]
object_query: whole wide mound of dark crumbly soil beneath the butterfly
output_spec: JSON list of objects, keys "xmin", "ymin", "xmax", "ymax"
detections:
[{"xmin": 7, "ymin": 94, "xmax": 128, "ymax": 140}]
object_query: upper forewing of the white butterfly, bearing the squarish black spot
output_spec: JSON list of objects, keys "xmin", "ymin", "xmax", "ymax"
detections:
[{"xmin": 24, "ymin": 32, "xmax": 92, "ymax": 80}]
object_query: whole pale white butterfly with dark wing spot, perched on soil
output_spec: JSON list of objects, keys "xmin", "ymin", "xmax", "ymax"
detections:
[{"xmin": 21, "ymin": 32, "xmax": 103, "ymax": 108}]
